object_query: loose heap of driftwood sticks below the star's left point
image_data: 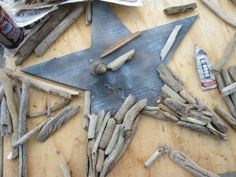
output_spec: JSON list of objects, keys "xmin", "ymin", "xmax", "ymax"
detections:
[{"xmin": 0, "ymin": 70, "xmax": 79, "ymax": 177}]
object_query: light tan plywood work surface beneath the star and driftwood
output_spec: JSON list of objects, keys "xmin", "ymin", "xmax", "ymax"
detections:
[{"xmin": 4, "ymin": 0, "xmax": 236, "ymax": 177}]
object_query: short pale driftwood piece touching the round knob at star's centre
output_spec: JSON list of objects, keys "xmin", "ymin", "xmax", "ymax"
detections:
[{"xmin": 107, "ymin": 49, "xmax": 134, "ymax": 71}]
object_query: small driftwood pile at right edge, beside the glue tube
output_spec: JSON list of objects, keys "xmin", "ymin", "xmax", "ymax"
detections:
[{"xmin": 215, "ymin": 66, "xmax": 236, "ymax": 130}]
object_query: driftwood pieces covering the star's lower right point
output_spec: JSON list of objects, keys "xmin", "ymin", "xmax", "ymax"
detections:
[{"xmin": 142, "ymin": 65, "xmax": 228, "ymax": 140}]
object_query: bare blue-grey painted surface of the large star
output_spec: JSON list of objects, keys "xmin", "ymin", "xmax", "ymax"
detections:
[{"xmin": 23, "ymin": 2, "xmax": 197, "ymax": 112}]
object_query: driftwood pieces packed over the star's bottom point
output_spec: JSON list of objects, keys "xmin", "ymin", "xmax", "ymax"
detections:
[{"xmin": 84, "ymin": 91, "xmax": 147, "ymax": 177}]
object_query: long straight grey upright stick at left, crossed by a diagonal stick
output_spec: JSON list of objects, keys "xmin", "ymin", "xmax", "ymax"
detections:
[{"xmin": 19, "ymin": 82, "xmax": 29, "ymax": 177}]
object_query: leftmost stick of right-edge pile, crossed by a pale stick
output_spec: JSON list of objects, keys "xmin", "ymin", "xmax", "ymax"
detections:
[{"xmin": 216, "ymin": 74, "xmax": 236, "ymax": 117}]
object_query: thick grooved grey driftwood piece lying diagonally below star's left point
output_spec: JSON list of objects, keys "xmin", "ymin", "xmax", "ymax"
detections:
[{"xmin": 38, "ymin": 106, "xmax": 79, "ymax": 142}]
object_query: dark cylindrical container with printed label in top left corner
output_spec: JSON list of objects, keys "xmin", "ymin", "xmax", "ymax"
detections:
[{"xmin": 0, "ymin": 6, "xmax": 24, "ymax": 49}]
